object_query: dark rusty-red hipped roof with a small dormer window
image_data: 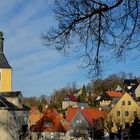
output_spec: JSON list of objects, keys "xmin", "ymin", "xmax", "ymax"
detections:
[{"xmin": 31, "ymin": 109, "xmax": 65, "ymax": 132}]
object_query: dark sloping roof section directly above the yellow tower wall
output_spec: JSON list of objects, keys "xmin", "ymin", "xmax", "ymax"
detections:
[{"xmin": 0, "ymin": 53, "xmax": 11, "ymax": 68}]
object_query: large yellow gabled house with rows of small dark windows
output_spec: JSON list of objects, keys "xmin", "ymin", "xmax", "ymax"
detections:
[{"xmin": 104, "ymin": 93, "xmax": 140, "ymax": 133}]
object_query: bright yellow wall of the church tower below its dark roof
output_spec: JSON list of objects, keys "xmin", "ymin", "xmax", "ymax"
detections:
[{"xmin": 0, "ymin": 69, "xmax": 12, "ymax": 92}]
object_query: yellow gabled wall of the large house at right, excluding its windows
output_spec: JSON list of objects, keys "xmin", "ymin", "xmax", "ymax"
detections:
[{"xmin": 105, "ymin": 93, "xmax": 140, "ymax": 132}]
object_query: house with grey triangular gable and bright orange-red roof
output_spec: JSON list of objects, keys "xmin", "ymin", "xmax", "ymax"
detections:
[{"xmin": 65, "ymin": 108, "xmax": 106, "ymax": 140}]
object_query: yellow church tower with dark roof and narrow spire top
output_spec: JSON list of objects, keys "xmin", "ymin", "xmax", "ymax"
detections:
[{"xmin": 0, "ymin": 31, "xmax": 12, "ymax": 92}]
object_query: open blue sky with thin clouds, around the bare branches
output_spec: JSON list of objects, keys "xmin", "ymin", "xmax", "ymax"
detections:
[{"xmin": 0, "ymin": 0, "xmax": 140, "ymax": 97}]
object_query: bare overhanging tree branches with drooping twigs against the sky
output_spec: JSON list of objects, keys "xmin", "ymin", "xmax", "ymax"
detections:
[{"xmin": 42, "ymin": 0, "xmax": 140, "ymax": 77}]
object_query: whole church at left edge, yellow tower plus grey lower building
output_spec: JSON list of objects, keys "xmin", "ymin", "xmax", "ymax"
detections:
[{"xmin": 0, "ymin": 31, "xmax": 30, "ymax": 140}]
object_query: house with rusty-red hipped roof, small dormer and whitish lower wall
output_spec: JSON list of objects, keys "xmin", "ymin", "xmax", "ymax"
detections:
[{"xmin": 31, "ymin": 109, "xmax": 66, "ymax": 140}]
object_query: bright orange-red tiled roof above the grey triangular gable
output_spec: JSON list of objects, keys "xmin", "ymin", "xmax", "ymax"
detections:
[{"xmin": 66, "ymin": 108, "xmax": 106, "ymax": 124}]
